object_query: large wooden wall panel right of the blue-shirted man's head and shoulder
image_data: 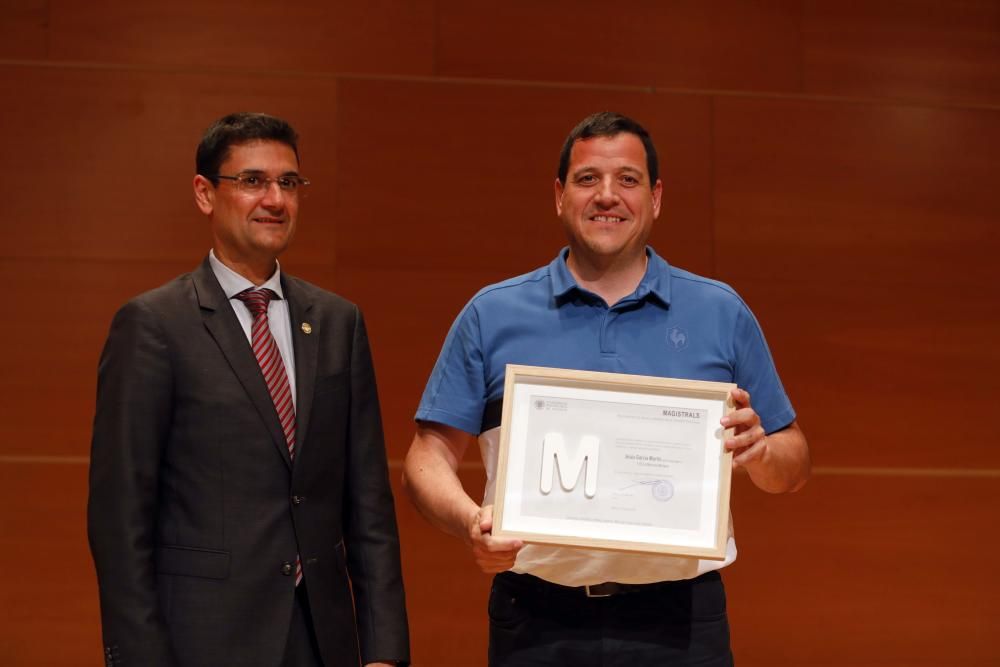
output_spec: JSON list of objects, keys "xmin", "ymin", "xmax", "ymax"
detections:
[{"xmin": 715, "ymin": 99, "xmax": 1000, "ymax": 467}]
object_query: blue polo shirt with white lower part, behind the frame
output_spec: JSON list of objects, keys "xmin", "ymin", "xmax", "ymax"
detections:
[{"xmin": 416, "ymin": 248, "xmax": 795, "ymax": 586}]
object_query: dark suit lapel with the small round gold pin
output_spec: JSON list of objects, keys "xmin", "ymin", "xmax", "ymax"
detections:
[{"xmin": 281, "ymin": 274, "xmax": 322, "ymax": 462}]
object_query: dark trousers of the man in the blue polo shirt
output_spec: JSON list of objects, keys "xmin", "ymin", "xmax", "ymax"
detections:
[{"xmin": 489, "ymin": 572, "xmax": 733, "ymax": 667}]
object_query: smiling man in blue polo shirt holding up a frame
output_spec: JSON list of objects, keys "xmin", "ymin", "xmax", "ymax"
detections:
[{"xmin": 403, "ymin": 113, "xmax": 810, "ymax": 667}]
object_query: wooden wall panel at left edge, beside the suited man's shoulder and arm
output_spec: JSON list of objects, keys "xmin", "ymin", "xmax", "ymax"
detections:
[{"xmin": 0, "ymin": 258, "xmax": 191, "ymax": 456}]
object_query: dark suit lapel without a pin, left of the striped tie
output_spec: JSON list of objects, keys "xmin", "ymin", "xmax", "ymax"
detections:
[{"xmin": 191, "ymin": 259, "xmax": 292, "ymax": 467}]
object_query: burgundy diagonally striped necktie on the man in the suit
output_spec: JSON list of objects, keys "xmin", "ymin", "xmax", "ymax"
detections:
[{"xmin": 235, "ymin": 288, "xmax": 302, "ymax": 586}]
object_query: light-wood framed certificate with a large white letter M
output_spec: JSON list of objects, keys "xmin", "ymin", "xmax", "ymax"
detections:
[{"xmin": 493, "ymin": 364, "xmax": 736, "ymax": 560}]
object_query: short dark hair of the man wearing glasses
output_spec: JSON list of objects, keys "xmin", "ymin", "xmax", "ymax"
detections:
[{"xmin": 194, "ymin": 111, "xmax": 299, "ymax": 185}]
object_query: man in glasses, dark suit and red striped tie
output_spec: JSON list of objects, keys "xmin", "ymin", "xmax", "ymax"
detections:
[{"xmin": 88, "ymin": 114, "xmax": 409, "ymax": 667}]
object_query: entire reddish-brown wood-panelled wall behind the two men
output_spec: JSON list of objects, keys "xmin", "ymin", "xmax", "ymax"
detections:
[{"xmin": 0, "ymin": 0, "xmax": 1000, "ymax": 667}]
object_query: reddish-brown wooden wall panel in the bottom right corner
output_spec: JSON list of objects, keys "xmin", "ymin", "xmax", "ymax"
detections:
[{"xmin": 724, "ymin": 475, "xmax": 1000, "ymax": 667}]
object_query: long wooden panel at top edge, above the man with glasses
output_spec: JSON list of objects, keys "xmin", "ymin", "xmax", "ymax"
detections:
[{"xmin": 43, "ymin": 0, "xmax": 433, "ymax": 75}]
